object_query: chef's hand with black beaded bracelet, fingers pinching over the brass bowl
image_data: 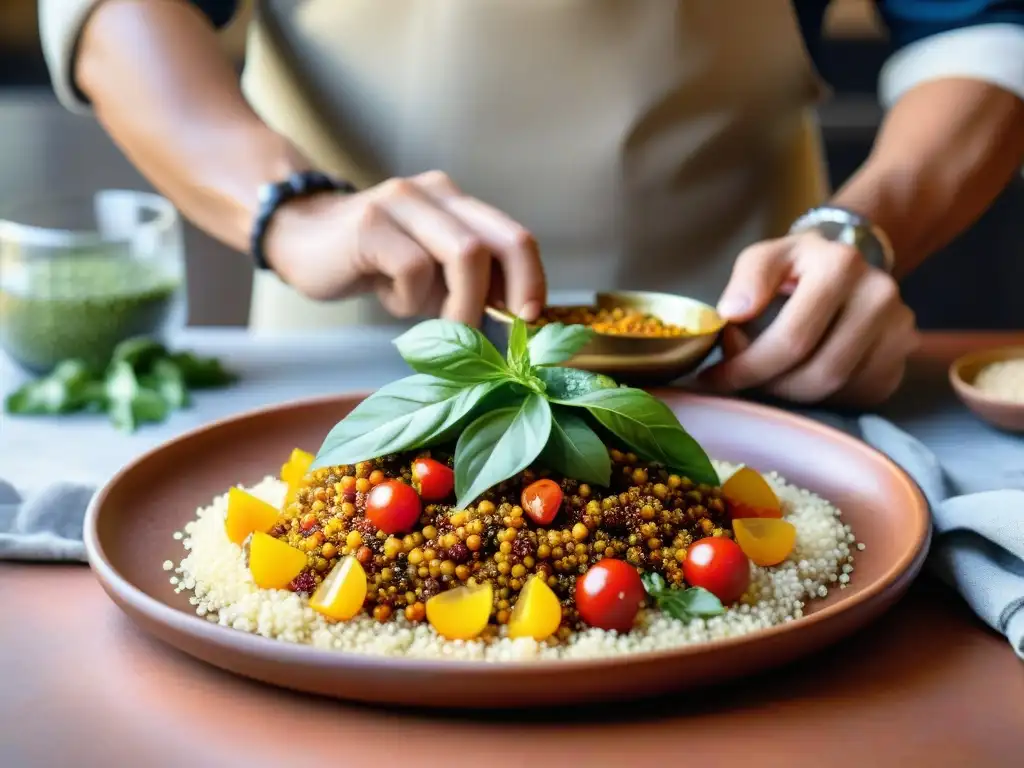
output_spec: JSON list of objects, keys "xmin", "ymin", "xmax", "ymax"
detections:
[{"xmin": 264, "ymin": 171, "xmax": 547, "ymax": 325}]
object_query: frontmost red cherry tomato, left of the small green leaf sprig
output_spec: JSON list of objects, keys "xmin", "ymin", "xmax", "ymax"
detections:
[{"xmin": 575, "ymin": 557, "xmax": 646, "ymax": 632}]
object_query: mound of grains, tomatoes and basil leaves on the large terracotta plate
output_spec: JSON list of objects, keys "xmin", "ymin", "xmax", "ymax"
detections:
[{"xmin": 164, "ymin": 322, "xmax": 860, "ymax": 662}]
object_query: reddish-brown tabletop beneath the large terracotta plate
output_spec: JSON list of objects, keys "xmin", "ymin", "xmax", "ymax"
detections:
[{"xmin": 0, "ymin": 334, "xmax": 1024, "ymax": 768}]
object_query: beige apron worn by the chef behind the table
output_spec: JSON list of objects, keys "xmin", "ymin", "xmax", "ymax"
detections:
[{"xmin": 237, "ymin": 0, "xmax": 826, "ymax": 330}]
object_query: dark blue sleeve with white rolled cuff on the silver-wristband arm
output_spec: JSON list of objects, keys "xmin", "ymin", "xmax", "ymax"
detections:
[{"xmin": 876, "ymin": 0, "xmax": 1024, "ymax": 106}]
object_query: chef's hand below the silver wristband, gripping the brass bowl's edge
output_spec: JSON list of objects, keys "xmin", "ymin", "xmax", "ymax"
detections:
[{"xmin": 702, "ymin": 232, "xmax": 918, "ymax": 407}]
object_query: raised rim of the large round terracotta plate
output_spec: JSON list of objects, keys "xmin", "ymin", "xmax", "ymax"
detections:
[{"xmin": 83, "ymin": 387, "xmax": 933, "ymax": 676}]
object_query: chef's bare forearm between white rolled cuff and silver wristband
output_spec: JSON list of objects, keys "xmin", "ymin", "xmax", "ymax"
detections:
[{"xmin": 833, "ymin": 78, "xmax": 1024, "ymax": 276}]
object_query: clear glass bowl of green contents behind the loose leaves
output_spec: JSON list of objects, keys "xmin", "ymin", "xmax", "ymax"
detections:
[{"xmin": 0, "ymin": 189, "xmax": 187, "ymax": 374}]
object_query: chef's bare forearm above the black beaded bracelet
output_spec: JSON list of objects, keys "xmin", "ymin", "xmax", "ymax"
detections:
[{"xmin": 75, "ymin": 0, "xmax": 306, "ymax": 250}]
